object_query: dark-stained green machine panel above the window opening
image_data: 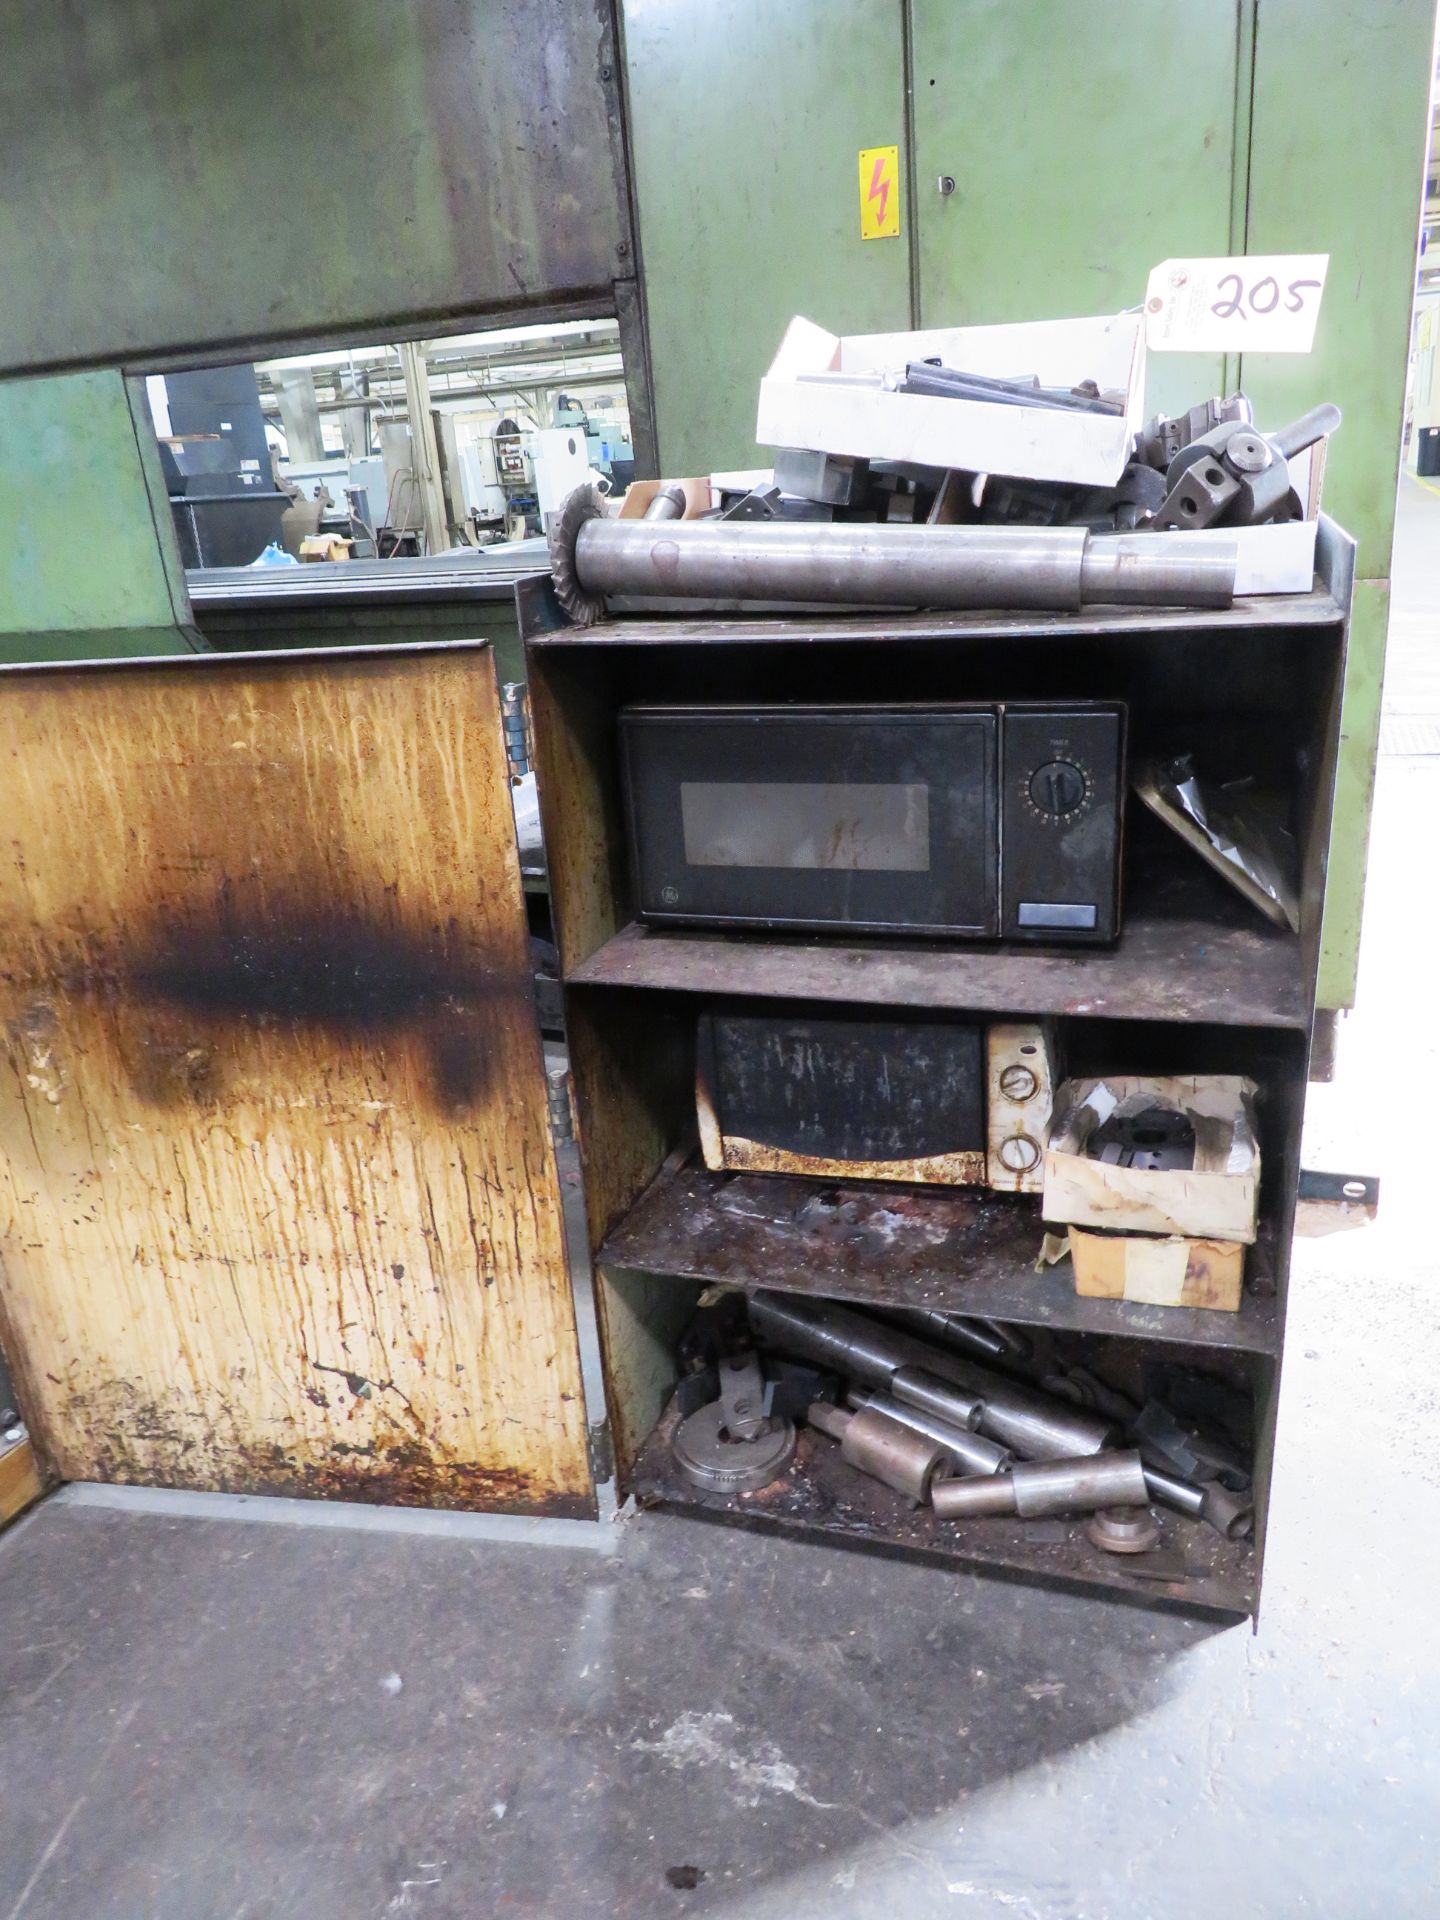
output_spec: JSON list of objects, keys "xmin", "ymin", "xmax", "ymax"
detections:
[{"xmin": 0, "ymin": 0, "xmax": 634, "ymax": 371}]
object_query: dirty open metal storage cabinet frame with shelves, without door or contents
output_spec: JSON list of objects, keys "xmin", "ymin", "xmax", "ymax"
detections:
[{"xmin": 518, "ymin": 520, "xmax": 1354, "ymax": 1615}]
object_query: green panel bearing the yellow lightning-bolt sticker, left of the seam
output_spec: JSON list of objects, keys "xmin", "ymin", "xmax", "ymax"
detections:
[{"xmin": 624, "ymin": 0, "xmax": 910, "ymax": 474}]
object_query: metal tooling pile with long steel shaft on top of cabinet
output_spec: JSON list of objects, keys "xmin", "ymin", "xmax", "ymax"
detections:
[{"xmin": 549, "ymin": 382, "xmax": 1340, "ymax": 626}]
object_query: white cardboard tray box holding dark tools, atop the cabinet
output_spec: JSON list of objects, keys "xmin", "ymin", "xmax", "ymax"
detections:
[{"xmin": 755, "ymin": 313, "xmax": 1144, "ymax": 486}]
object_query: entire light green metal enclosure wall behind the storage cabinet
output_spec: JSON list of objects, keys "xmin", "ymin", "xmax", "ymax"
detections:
[{"xmin": 622, "ymin": 0, "xmax": 1434, "ymax": 1006}]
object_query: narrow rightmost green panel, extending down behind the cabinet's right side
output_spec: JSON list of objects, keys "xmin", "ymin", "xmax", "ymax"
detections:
[{"xmin": 1242, "ymin": 0, "xmax": 1434, "ymax": 1006}]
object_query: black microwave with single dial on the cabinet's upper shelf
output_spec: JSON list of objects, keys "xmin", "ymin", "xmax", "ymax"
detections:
[{"xmin": 620, "ymin": 701, "xmax": 1125, "ymax": 943}]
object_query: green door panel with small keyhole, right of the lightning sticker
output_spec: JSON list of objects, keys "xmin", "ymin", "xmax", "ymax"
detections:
[{"xmin": 912, "ymin": 0, "xmax": 1248, "ymax": 413}]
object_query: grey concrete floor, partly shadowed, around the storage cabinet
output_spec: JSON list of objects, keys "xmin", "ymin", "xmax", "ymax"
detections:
[{"xmin": 0, "ymin": 480, "xmax": 1440, "ymax": 1920}]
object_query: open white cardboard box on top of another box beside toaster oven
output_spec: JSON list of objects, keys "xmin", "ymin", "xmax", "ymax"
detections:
[{"xmin": 1041, "ymin": 1073, "xmax": 1260, "ymax": 1246}]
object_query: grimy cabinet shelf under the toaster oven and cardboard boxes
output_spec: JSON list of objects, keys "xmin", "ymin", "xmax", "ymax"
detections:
[{"xmin": 597, "ymin": 1158, "xmax": 1281, "ymax": 1356}]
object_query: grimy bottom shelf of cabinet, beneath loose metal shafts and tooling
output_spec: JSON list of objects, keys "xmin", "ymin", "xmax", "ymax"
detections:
[{"xmin": 634, "ymin": 1405, "xmax": 1256, "ymax": 1619}]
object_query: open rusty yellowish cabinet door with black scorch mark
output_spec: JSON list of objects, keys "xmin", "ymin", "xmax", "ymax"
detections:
[{"xmin": 0, "ymin": 645, "xmax": 593, "ymax": 1515}]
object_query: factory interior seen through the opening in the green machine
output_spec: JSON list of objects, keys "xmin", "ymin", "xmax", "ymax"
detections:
[{"xmin": 146, "ymin": 319, "xmax": 634, "ymax": 568}]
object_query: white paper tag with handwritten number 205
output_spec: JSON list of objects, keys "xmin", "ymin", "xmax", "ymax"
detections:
[{"xmin": 1144, "ymin": 253, "xmax": 1331, "ymax": 353}]
